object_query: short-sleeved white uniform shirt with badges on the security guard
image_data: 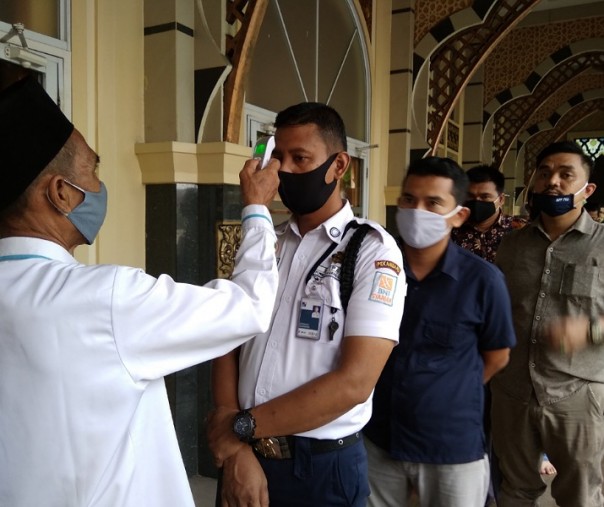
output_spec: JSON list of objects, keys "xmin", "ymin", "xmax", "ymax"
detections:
[{"xmin": 239, "ymin": 203, "xmax": 406, "ymax": 439}]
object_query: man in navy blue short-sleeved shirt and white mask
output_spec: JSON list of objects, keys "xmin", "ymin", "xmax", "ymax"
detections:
[{"xmin": 365, "ymin": 157, "xmax": 515, "ymax": 507}]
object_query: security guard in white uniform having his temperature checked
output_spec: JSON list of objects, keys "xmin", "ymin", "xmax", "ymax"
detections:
[{"xmin": 208, "ymin": 103, "xmax": 406, "ymax": 507}]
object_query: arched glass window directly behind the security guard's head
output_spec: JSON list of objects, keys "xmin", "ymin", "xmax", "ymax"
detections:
[{"xmin": 245, "ymin": 0, "xmax": 370, "ymax": 216}]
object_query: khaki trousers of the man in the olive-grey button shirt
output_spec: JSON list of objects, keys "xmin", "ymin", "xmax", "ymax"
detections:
[{"xmin": 491, "ymin": 383, "xmax": 604, "ymax": 507}]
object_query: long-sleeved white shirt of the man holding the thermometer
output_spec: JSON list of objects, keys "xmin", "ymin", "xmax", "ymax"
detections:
[{"xmin": 0, "ymin": 206, "xmax": 277, "ymax": 507}]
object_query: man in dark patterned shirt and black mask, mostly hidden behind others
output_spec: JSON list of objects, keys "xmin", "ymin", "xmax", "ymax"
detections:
[{"xmin": 451, "ymin": 165, "xmax": 514, "ymax": 262}]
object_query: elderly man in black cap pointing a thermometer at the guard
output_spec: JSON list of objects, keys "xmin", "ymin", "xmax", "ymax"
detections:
[{"xmin": 0, "ymin": 78, "xmax": 279, "ymax": 507}]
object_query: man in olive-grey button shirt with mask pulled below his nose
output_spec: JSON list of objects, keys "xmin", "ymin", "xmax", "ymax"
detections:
[{"xmin": 491, "ymin": 141, "xmax": 604, "ymax": 507}]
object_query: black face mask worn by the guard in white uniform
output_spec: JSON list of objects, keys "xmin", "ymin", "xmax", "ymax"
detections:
[{"xmin": 279, "ymin": 153, "xmax": 338, "ymax": 215}]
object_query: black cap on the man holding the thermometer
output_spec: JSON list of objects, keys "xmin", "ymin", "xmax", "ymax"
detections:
[{"xmin": 0, "ymin": 77, "xmax": 74, "ymax": 210}]
